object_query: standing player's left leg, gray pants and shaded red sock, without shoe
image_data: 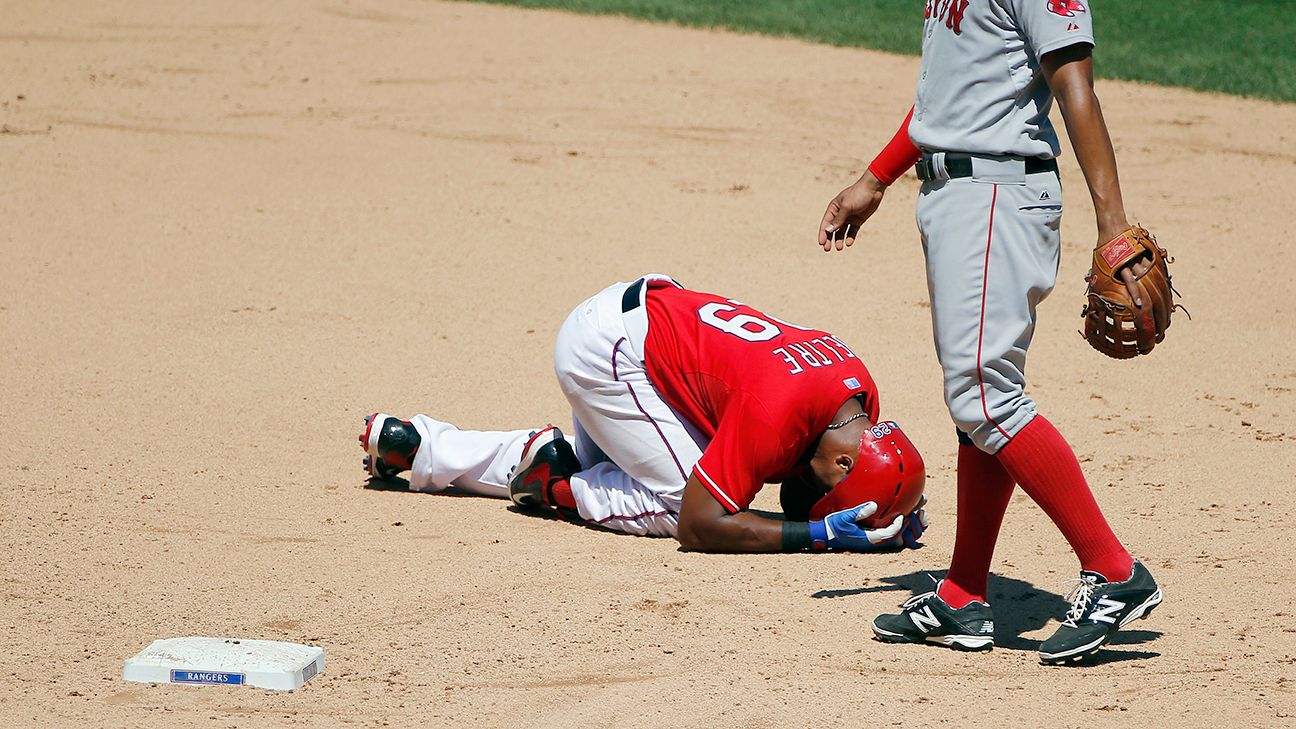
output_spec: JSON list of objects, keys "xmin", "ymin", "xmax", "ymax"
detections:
[{"xmin": 918, "ymin": 170, "xmax": 1061, "ymax": 608}]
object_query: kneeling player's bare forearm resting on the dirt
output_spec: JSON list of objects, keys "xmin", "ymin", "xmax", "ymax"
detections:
[{"xmin": 678, "ymin": 473, "xmax": 811, "ymax": 551}]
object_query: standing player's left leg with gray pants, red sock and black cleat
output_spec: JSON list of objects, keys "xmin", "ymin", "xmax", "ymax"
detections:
[{"xmin": 874, "ymin": 170, "xmax": 1041, "ymax": 650}]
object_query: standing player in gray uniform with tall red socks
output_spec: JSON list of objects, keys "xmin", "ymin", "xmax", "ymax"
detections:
[{"xmin": 818, "ymin": 0, "xmax": 1168, "ymax": 663}]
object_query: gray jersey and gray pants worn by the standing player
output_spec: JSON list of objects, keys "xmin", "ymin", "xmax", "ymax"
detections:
[{"xmin": 908, "ymin": 0, "xmax": 1094, "ymax": 453}]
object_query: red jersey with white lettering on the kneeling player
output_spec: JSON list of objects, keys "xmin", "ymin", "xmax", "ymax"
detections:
[{"xmin": 644, "ymin": 281, "xmax": 877, "ymax": 512}]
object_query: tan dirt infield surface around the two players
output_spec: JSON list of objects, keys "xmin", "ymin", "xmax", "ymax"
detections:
[{"xmin": 0, "ymin": 0, "xmax": 1296, "ymax": 726}]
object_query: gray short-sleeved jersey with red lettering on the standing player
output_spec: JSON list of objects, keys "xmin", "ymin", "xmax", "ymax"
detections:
[{"xmin": 908, "ymin": 0, "xmax": 1094, "ymax": 157}]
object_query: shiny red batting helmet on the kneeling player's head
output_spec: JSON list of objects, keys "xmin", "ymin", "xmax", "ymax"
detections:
[{"xmin": 810, "ymin": 420, "xmax": 927, "ymax": 527}]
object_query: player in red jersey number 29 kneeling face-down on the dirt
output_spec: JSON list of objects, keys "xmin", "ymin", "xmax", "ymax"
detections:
[{"xmin": 360, "ymin": 275, "xmax": 927, "ymax": 551}]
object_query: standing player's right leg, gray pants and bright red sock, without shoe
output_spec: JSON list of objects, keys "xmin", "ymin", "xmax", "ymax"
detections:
[{"xmin": 928, "ymin": 173, "xmax": 1133, "ymax": 581}]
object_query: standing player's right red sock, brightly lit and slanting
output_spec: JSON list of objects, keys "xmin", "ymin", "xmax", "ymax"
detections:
[{"xmin": 995, "ymin": 415, "xmax": 1134, "ymax": 582}]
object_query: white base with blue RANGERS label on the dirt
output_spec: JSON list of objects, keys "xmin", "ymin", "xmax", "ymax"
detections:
[{"xmin": 122, "ymin": 638, "xmax": 324, "ymax": 691}]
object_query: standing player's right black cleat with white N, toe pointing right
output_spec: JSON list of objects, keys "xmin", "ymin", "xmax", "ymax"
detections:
[{"xmin": 1039, "ymin": 560, "xmax": 1161, "ymax": 665}]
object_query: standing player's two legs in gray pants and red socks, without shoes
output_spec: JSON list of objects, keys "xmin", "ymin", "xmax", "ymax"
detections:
[{"xmin": 875, "ymin": 163, "xmax": 1159, "ymax": 655}]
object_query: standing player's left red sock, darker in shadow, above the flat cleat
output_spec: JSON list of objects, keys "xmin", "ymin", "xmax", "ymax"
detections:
[{"xmin": 936, "ymin": 436, "xmax": 1013, "ymax": 610}]
